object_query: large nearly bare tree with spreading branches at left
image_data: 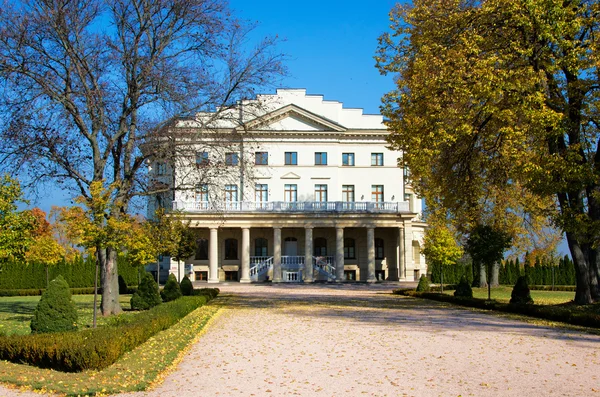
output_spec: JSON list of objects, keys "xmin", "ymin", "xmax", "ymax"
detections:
[{"xmin": 0, "ymin": 0, "xmax": 284, "ymax": 315}]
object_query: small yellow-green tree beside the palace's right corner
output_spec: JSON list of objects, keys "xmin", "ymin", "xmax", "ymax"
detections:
[{"xmin": 423, "ymin": 221, "xmax": 463, "ymax": 292}]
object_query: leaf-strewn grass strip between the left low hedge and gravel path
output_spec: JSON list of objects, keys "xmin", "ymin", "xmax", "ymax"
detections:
[{"xmin": 0, "ymin": 298, "xmax": 227, "ymax": 396}]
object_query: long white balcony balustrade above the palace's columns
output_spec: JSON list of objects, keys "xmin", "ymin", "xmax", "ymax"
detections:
[{"xmin": 173, "ymin": 201, "xmax": 410, "ymax": 214}]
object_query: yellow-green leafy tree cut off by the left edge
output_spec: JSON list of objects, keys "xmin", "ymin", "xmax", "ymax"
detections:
[{"xmin": 0, "ymin": 175, "xmax": 35, "ymax": 260}]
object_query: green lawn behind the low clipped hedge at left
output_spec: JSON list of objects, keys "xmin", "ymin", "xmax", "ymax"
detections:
[{"xmin": 0, "ymin": 295, "xmax": 136, "ymax": 335}]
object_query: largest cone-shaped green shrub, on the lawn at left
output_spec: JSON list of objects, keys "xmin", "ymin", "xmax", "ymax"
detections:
[{"xmin": 30, "ymin": 276, "xmax": 77, "ymax": 334}]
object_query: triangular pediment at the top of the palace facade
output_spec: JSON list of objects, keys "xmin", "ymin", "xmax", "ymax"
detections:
[{"xmin": 239, "ymin": 104, "xmax": 346, "ymax": 132}]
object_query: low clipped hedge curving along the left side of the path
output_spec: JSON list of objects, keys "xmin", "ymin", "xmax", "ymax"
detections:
[{"xmin": 0, "ymin": 293, "xmax": 219, "ymax": 372}]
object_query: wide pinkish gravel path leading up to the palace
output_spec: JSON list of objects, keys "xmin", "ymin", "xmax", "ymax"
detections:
[{"xmin": 0, "ymin": 284, "xmax": 600, "ymax": 397}]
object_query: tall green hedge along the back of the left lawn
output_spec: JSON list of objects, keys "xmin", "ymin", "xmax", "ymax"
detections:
[{"xmin": 0, "ymin": 255, "xmax": 140, "ymax": 289}]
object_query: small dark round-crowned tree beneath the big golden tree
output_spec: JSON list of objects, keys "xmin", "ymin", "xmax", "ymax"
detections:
[{"xmin": 466, "ymin": 224, "xmax": 512, "ymax": 300}]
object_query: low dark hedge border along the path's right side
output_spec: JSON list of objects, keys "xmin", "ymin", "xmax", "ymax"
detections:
[{"xmin": 393, "ymin": 289, "xmax": 600, "ymax": 328}]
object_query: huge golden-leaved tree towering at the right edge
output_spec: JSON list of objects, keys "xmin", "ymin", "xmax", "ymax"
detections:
[{"xmin": 377, "ymin": 0, "xmax": 600, "ymax": 304}]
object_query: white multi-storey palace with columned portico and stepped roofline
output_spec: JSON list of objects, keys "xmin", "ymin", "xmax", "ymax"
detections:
[{"xmin": 148, "ymin": 89, "xmax": 427, "ymax": 283}]
